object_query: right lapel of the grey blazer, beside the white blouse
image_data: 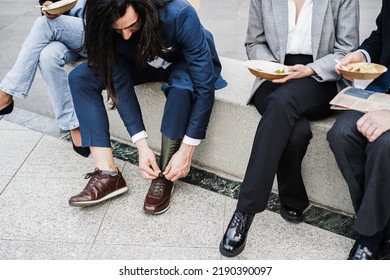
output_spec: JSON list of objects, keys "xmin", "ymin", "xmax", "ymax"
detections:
[{"xmin": 311, "ymin": 0, "xmax": 329, "ymax": 59}]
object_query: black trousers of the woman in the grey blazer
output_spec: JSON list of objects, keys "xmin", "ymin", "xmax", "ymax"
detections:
[{"xmin": 237, "ymin": 55, "xmax": 337, "ymax": 213}]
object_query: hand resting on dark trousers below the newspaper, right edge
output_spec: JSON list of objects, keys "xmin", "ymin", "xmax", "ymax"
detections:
[{"xmin": 356, "ymin": 110, "xmax": 390, "ymax": 142}]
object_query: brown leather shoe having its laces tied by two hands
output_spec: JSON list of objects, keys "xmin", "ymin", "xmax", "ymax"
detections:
[{"xmin": 143, "ymin": 177, "xmax": 174, "ymax": 215}]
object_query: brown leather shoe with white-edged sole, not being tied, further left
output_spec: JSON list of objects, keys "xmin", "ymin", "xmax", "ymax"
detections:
[{"xmin": 69, "ymin": 168, "xmax": 129, "ymax": 207}]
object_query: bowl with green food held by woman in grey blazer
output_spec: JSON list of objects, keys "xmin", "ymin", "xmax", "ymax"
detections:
[{"xmin": 244, "ymin": 60, "xmax": 291, "ymax": 80}]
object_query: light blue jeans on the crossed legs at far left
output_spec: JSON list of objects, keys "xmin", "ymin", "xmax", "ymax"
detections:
[{"xmin": 0, "ymin": 15, "xmax": 85, "ymax": 130}]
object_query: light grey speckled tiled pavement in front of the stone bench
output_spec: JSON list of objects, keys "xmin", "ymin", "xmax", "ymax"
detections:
[{"xmin": 0, "ymin": 120, "xmax": 352, "ymax": 260}]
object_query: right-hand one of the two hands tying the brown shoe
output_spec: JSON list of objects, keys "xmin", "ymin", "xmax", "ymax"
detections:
[{"xmin": 163, "ymin": 143, "xmax": 196, "ymax": 182}]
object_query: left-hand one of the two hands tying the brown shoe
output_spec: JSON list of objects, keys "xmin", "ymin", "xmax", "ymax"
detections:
[{"xmin": 135, "ymin": 139, "xmax": 161, "ymax": 179}]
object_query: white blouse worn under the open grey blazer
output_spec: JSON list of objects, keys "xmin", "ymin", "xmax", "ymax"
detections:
[{"xmin": 286, "ymin": 0, "xmax": 313, "ymax": 55}]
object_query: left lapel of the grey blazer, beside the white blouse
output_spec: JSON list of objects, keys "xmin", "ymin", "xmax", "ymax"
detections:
[{"xmin": 269, "ymin": 0, "xmax": 288, "ymax": 63}]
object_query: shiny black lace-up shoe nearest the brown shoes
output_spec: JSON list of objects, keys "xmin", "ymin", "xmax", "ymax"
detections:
[{"xmin": 219, "ymin": 210, "xmax": 255, "ymax": 258}]
